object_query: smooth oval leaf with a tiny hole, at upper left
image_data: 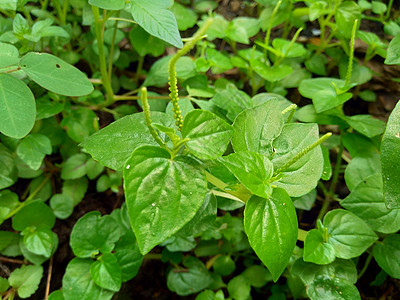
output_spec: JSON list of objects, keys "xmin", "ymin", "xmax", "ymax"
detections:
[{"xmin": 20, "ymin": 52, "xmax": 93, "ymax": 97}]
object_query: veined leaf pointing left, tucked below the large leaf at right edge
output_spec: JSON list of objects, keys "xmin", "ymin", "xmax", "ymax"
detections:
[{"xmin": 340, "ymin": 173, "xmax": 400, "ymax": 233}]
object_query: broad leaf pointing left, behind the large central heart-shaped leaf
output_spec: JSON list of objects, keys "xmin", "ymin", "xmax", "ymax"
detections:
[{"xmin": 81, "ymin": 112, "xmax": 175, "ymax": 170}]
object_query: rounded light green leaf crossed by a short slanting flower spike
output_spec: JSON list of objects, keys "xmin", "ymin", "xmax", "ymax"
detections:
[{"xmin": 272, "ymin": 123, "xmax": 324, "ymax": 197}]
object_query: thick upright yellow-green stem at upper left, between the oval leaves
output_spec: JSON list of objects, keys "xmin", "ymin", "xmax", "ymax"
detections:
[{"xmin": 92, "ymin": 6, "xmax": 114, "ymax": 107}]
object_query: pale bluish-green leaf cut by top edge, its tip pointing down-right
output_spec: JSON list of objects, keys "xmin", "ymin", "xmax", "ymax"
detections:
[{"xmin": 130, "ymin": 0, "xmax": 183, "ymax": 48}]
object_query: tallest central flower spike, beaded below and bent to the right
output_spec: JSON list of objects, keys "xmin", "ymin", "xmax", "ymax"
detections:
[{"xmin": 168, "ymin": 18, "xmax": 213, "ymax": 130}]
